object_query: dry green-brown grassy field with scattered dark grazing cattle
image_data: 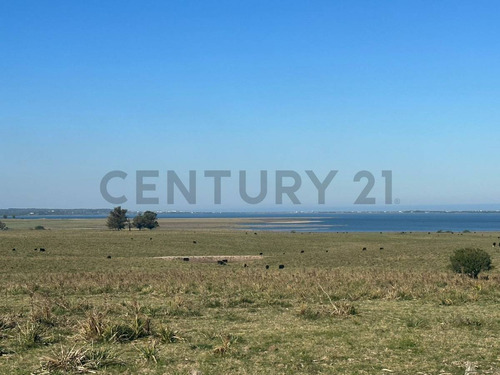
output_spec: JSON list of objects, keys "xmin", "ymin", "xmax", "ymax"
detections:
[{"xmin": 0, "ymin": 219, "xmax": 500, "ymax": 374}]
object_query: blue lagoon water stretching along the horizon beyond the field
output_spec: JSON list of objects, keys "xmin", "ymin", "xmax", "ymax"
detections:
[{"xmin": 14, "ymin": 212, "xmax": 500, "ymax": 232}]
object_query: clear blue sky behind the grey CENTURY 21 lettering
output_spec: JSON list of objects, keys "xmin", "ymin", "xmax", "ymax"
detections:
[{"xmin": 0, "ymin": 0, "xmax": 500, "ymax": 210}]
